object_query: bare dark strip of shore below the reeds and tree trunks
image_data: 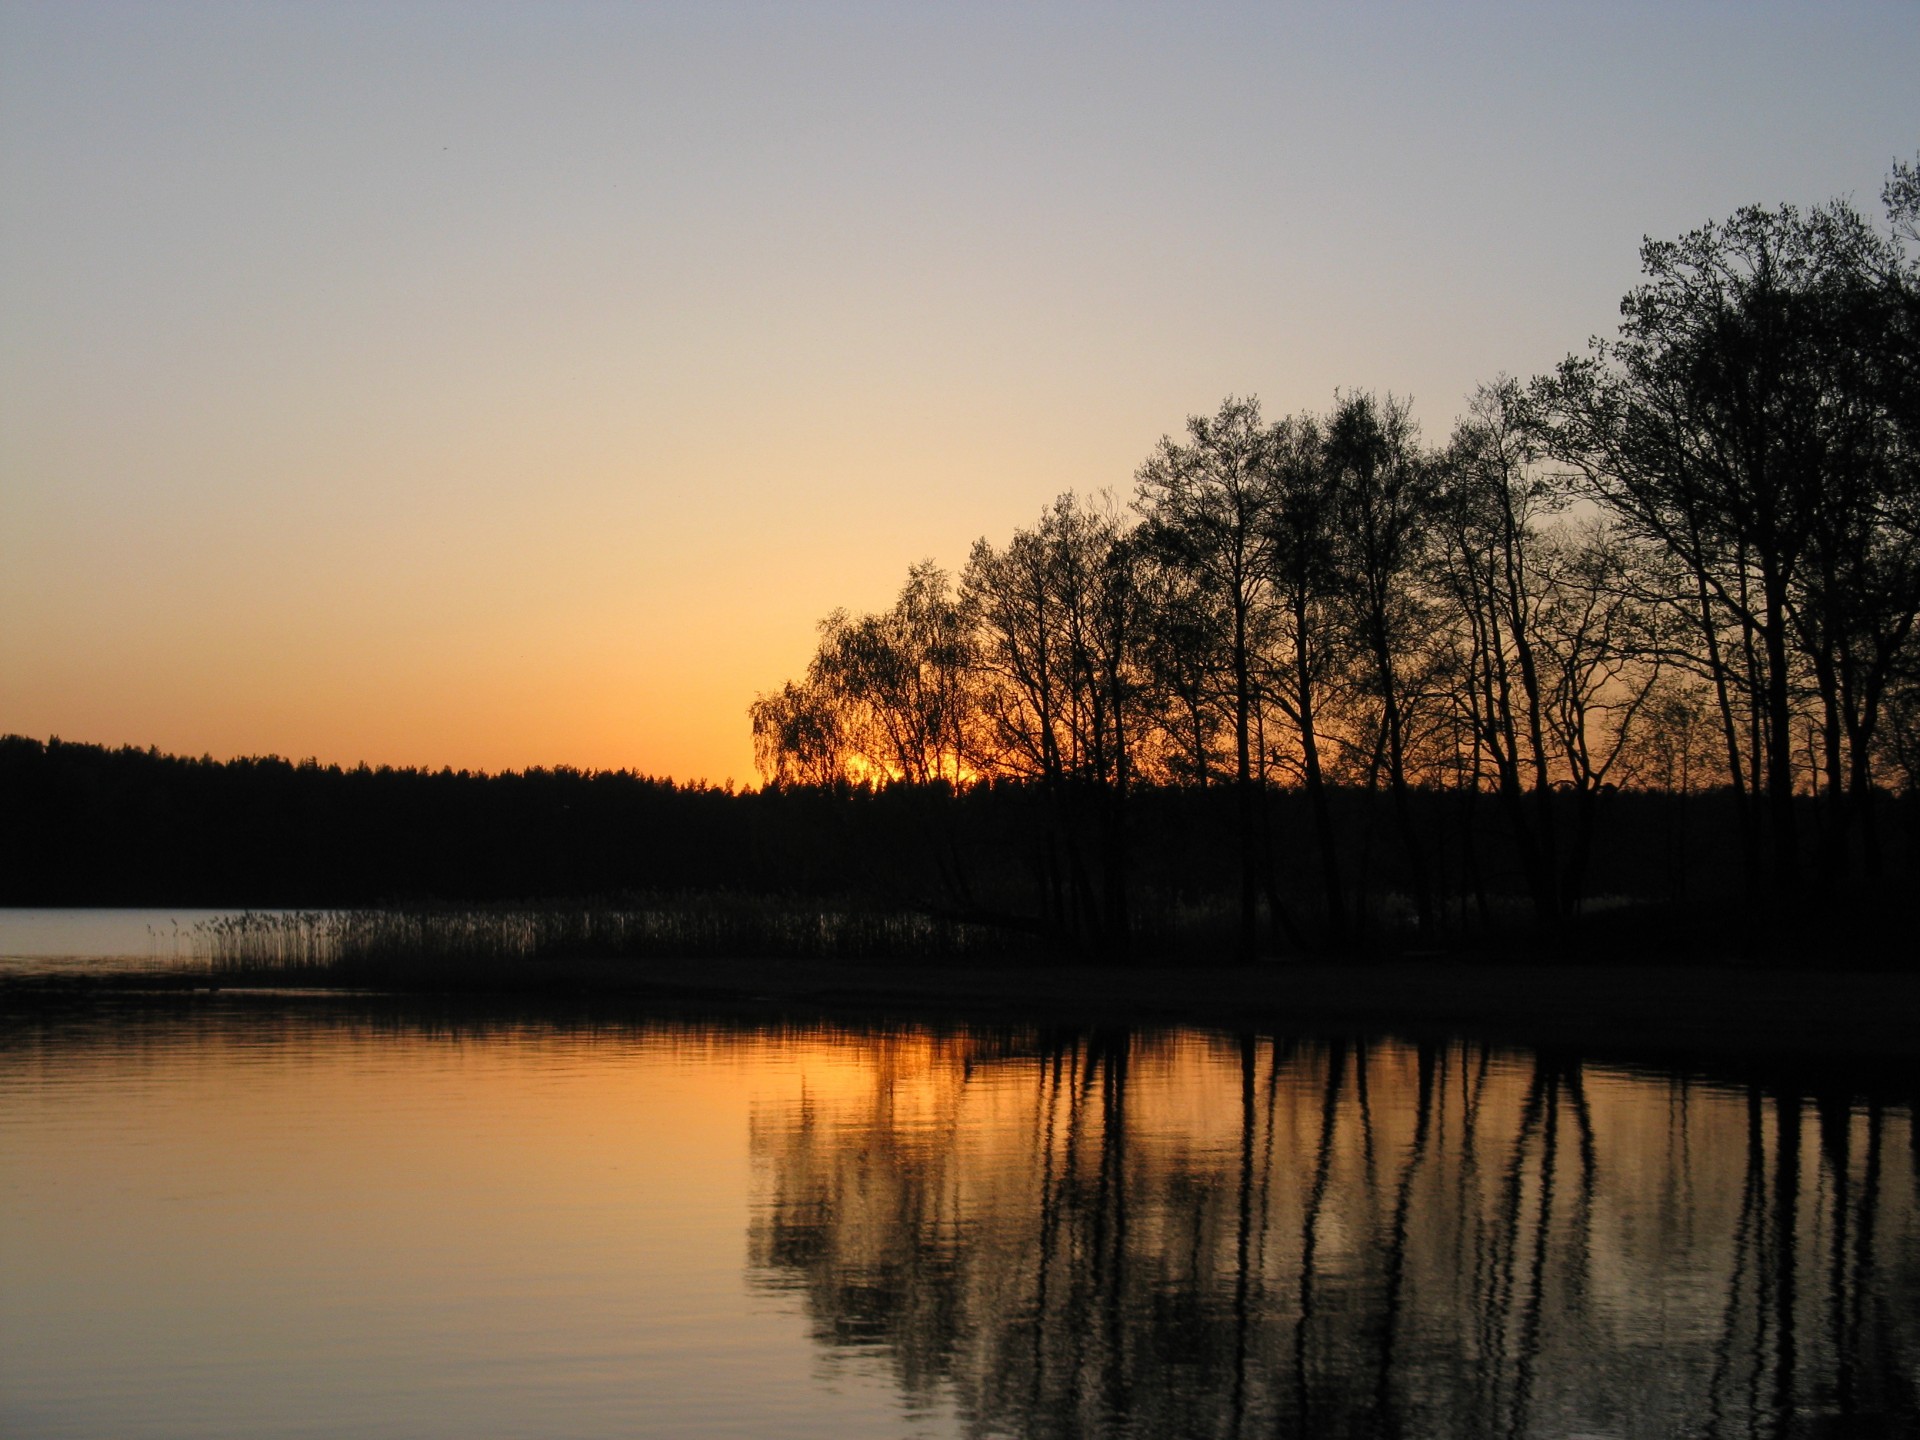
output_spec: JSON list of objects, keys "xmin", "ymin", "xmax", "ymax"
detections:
[{"xmin": 15, "ymin": 960, "xmax": 1920, "ymax": 1075}]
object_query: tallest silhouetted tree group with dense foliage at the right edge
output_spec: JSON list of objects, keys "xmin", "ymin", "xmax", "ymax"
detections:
[{"xmin": 1534, "ymin": 171, "xmax": 1920, "ymax": 891}]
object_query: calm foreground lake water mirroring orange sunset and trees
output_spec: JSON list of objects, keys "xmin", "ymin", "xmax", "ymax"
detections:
[{"xmin": 0, "ymin": 996, "xmax": 1920, "ymax": 1438}]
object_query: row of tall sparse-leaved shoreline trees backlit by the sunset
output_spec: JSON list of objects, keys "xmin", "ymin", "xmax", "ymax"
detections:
[{"xmin": 751, "ymin": 163, "xmax": 1920, "ymax": 956}]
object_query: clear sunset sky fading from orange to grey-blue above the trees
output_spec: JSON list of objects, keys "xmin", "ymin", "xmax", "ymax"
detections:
[{"xmin": 0, "ymin": 0, "xmax": 1920, "ymax": 781}]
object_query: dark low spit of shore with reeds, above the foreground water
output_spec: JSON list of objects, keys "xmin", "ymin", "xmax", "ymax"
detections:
[{"xmin": 10, "ymin": 893, "xmax": 1920, "ymax": 1075}]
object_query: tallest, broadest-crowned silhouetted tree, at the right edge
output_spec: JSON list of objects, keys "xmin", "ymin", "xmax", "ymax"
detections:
[{"xmin": 1536, "ymin": 192, "xmax": 1910, "ymax": 885}]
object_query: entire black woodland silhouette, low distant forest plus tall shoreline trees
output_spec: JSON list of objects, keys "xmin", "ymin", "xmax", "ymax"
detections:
[{"xmin": 0, "ymin": 163, "xmax": 1920, "ymax": 958}]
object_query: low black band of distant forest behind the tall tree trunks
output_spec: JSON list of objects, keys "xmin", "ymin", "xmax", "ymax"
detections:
[{"xmin": 0, "ymin": 735, "xmax": 1789, "ymax": 958}]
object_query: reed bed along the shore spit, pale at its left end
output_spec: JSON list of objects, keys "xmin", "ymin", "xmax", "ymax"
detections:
[{"xmin": 194, "ymin": 895, "xmax": 1023, "ymax": 985}]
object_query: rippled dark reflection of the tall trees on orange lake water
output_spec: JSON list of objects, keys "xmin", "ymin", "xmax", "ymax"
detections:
[{"xmin": 751, "ymin": 1031, "xmax": 1920, "ymax": 1436}]
